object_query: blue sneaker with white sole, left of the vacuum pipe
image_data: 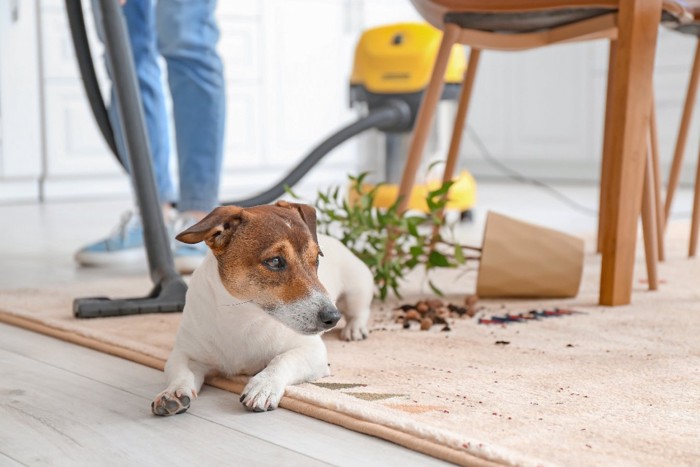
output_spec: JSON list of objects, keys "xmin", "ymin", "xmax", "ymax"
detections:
[{"xmin": 75, "ymin": 211, "xmax": 146, "ymax": 266}]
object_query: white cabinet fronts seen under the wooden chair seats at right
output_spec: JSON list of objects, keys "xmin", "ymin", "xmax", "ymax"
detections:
[{"xmin": 462, "ymin": 28, "xmax": 700, "ymax": 182}]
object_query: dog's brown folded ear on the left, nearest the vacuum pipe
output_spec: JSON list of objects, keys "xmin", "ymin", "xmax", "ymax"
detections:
[{"xmin": 175, "ymin": 206, "xmax": 243, "ymax": 250}]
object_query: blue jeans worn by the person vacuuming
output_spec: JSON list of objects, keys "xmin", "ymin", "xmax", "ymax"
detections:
[{"xmin": 93, "ymin": 0, "xmax": 226, "ymax": 211}]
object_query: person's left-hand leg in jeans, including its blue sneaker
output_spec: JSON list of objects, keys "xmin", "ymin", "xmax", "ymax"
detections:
[{"xmin": 75, "ymin": 0, "xmax": 175, "ymax": 265}]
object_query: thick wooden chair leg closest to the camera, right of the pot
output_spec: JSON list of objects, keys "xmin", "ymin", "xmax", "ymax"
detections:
[{"xmin": 599, "ymin": 0, "xmax": 662, "ymax": 306}]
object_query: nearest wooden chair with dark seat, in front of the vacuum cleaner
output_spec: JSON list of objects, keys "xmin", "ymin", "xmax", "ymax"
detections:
[{"xmin": 399, "ymin": 0, "xmax": 689, "ymax": 305}]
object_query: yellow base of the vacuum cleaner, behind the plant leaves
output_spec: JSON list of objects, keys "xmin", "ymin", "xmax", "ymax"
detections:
[{"xmin": 350, "ymin": 170, "xmax": 476, "ymax": 213}]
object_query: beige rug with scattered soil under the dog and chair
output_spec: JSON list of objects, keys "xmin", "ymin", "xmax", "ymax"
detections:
[{"xmin": 0, "ymin": 228, "xmax": 700, "ymax": 466}]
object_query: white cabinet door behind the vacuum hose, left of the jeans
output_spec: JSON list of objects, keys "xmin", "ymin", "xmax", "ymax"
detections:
[{"xmin": 39, "ymin": 0, "xmax": 130, "ymax": 199}]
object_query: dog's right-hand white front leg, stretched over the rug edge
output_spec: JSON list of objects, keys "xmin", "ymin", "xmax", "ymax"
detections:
[{"xmin": 240, "ymin": 342, "xmax": 330, "ymax": 412}]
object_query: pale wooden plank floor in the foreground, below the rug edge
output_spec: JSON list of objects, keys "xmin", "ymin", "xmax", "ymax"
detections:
[{"xmin": 0, "ymin": 324, "xmax": 448, "ymax": 466}]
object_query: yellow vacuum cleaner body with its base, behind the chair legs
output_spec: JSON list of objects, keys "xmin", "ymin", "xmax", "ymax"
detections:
[{"xmin": 350, "ymin": 23, "xmax": 476, "ymax": 214}]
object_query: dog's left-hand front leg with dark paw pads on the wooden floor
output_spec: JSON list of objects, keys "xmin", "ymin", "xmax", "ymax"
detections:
[{"xmin": 151, "ymin": 348, "xmax": 209, "ymax": 415}]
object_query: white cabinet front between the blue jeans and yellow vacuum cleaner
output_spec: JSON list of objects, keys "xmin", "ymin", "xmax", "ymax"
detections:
[{"xmin": 219, "ymin": 0, "xmax": 359, "ymax": 199}]
